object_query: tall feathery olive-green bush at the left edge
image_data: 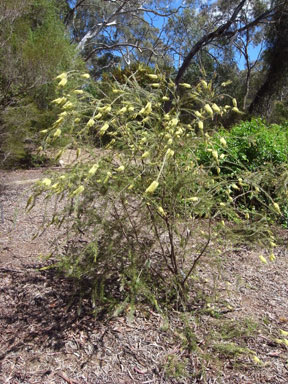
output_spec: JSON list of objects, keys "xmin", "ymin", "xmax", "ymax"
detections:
[{"xmin": 0, "ymin": 0, "xmax": 79, "ymax": 166}]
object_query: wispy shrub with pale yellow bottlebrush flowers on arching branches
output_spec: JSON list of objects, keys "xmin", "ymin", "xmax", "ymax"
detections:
[{"xmin": 28, "ymin": 72, "xmax": 280, "ymax": 307}]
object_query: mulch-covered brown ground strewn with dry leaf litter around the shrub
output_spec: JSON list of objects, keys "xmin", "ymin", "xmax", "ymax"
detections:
[{"xmin": 0, "ymin": 169, "xmax": 288, "ymax": 384}]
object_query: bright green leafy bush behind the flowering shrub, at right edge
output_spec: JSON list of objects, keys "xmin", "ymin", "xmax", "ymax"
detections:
[{"xmin": 198, "ymin": 119, "xmax": 288, "ymax": 222}]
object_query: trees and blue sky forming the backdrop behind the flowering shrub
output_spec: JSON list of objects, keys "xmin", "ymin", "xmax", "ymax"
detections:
[{"xmin": 0, "ymin": 0, "xmax": 287, "ymax": 165}]
